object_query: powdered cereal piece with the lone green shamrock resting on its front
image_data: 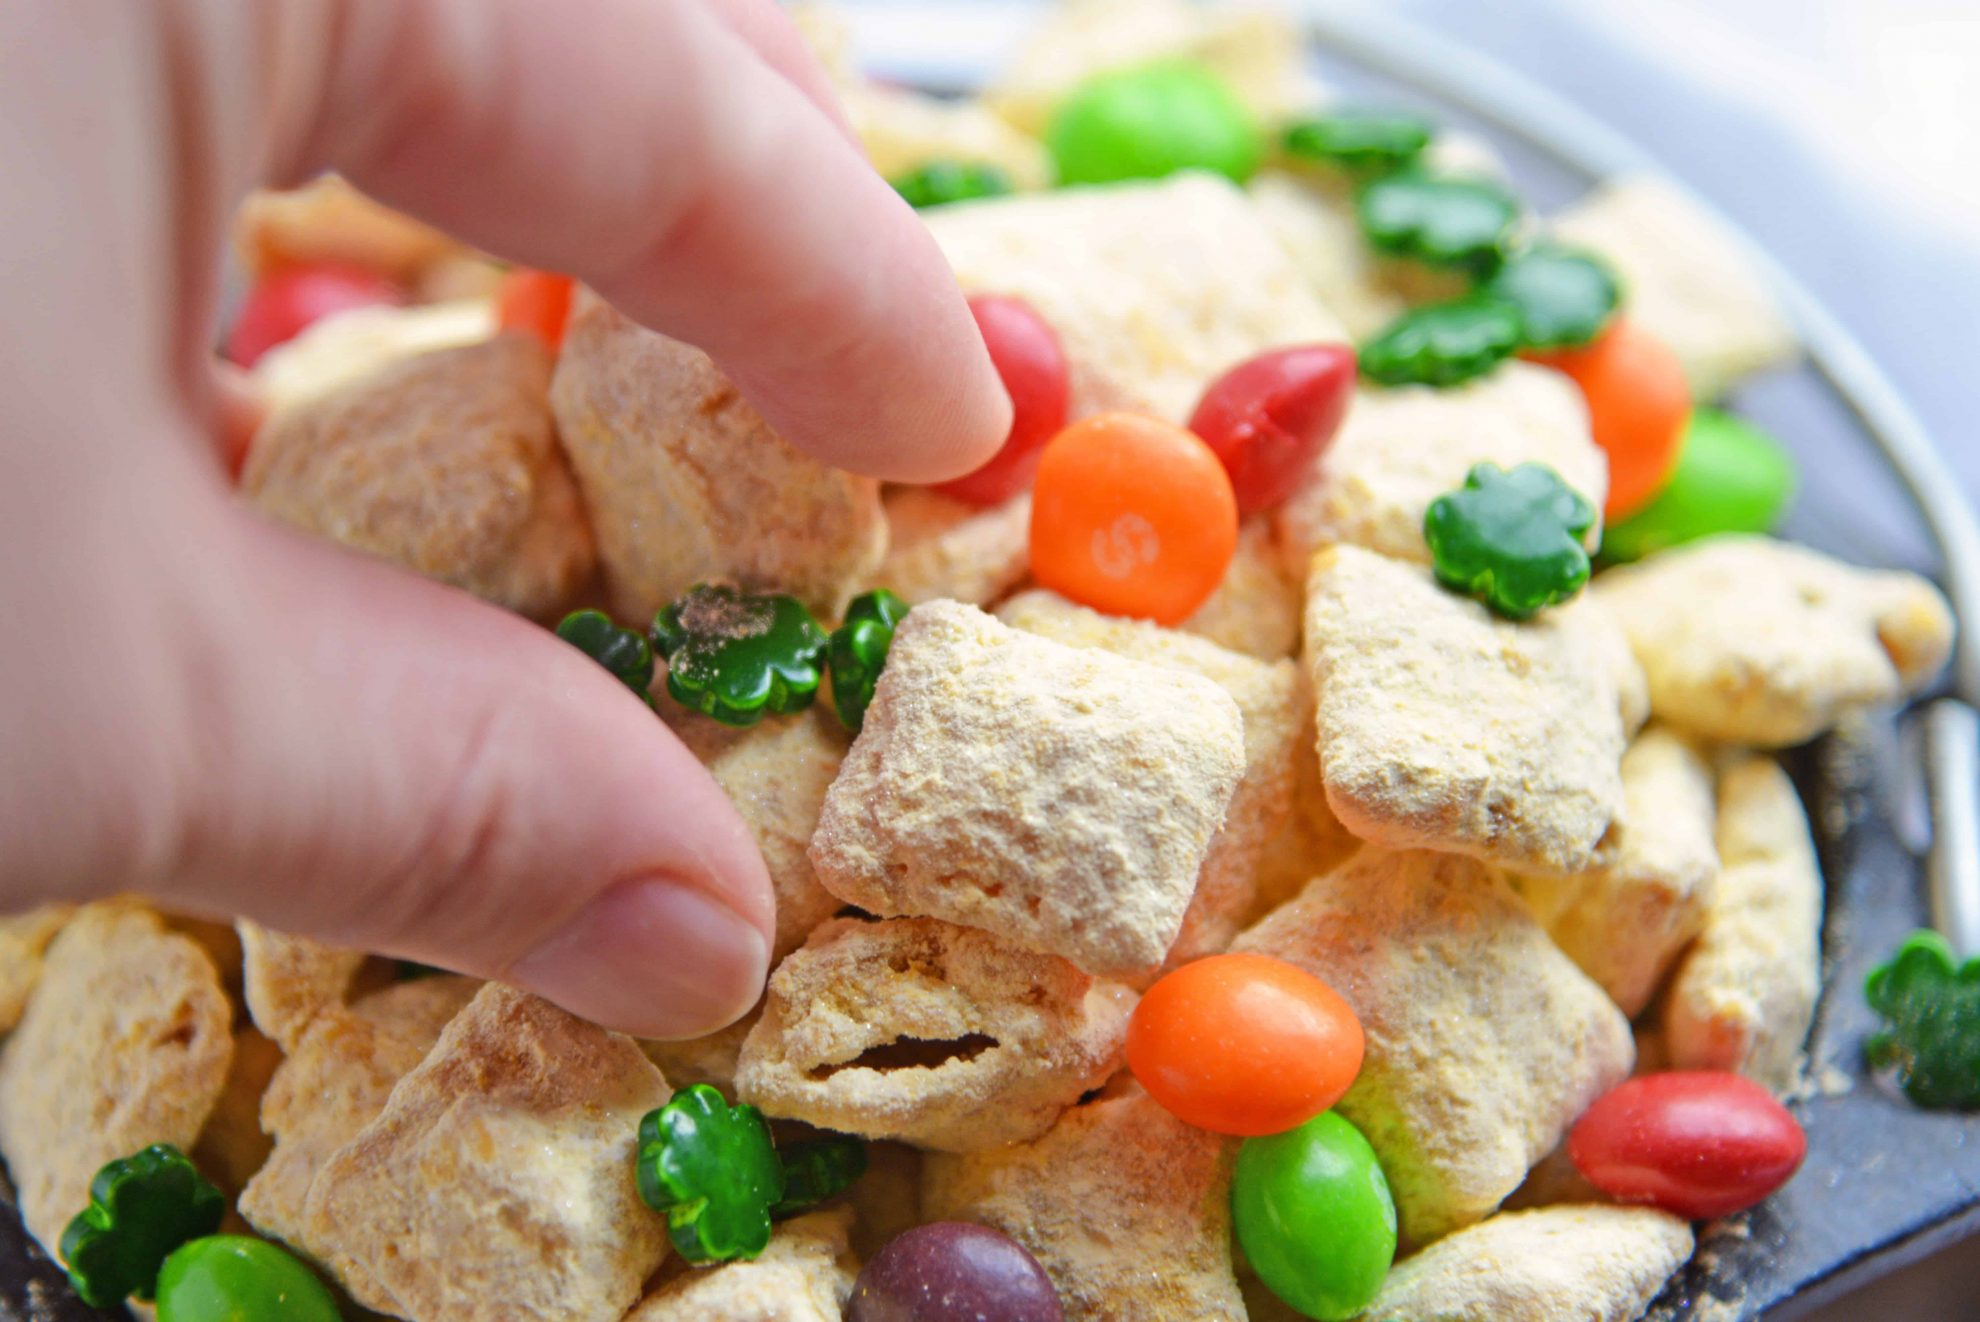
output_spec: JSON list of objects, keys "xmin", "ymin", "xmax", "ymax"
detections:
[{"xmin": 1277, "ymin": 362, "xmax": 1608, "ymax": 568}]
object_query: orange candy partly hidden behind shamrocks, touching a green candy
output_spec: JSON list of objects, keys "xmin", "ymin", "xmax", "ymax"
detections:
[{"xmin": 1533, "ymin": 317, "xmax": 1691, "ymax": 522}]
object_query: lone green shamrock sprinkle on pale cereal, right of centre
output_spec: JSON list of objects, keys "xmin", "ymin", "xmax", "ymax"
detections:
[{"xmin": 1424, "ymin": 463, "xmax": 1596, "ymax": 619}]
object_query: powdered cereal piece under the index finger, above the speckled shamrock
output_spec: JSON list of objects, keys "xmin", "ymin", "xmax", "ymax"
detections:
[{"xmin": 550, "ymin": 295, "xmax": 887, "ymax": 619}]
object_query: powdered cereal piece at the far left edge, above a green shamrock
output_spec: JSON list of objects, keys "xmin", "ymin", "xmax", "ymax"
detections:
[{"xmin": 0, "ymin": 900, "xmax": 234, "ymax": 1255}]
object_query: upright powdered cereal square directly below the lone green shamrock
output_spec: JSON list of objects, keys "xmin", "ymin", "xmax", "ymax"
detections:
[{"xmin": 1307, "ymin": 546, "xmax": 1626, "ymax": 873}]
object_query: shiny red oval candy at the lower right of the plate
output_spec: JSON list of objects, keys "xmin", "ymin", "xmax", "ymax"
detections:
[{"xmin": 1568, "ymin": 1071, "xmax": 1808, "ymax": 1221}]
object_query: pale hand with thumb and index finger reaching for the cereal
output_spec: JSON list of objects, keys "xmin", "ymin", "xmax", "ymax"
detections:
[{"xmin": 0, "ymin": 0, "xmax": 1010, "ymax": 1037}]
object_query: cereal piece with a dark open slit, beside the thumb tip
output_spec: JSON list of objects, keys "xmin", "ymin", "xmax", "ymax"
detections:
[{"xmin": 737, "ymin": 918, "xmax": 1135, "ymax": 1152}]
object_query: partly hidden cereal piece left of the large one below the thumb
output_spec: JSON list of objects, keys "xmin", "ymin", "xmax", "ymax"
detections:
[{"xmin": 240, "ymin": 976, "xmax": 481, "ymax": 1266}]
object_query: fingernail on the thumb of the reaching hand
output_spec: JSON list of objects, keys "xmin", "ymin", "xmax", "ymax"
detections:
[{"xmin": 509, "ymin": 879, "xmax": 770, "ymax": 1037}]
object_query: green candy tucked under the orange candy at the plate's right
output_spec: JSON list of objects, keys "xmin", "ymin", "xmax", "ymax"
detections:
[{"xmin": 1602, "ymin": 408, "xmax": 1794, "ymax": 562}]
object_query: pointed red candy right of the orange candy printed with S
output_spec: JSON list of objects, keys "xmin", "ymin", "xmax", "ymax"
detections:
[{"xmin": 1190, "ymin": 344, "xmax": 1354, "ymax": 515}]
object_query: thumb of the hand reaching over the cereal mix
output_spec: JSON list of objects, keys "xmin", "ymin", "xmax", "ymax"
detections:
[{"xmin": 172, "ymin": 515, "xmax": 774, "ymax": 1037}]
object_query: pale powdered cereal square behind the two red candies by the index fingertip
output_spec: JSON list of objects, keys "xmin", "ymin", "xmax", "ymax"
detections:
[{"xmin": 927, "ymin": 174, "xmax": 1342, "ymax": 422}]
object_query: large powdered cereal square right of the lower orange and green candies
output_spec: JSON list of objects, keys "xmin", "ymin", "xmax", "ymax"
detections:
[{"xmin": 1236, "ymin": 849, "xmax": 1634, "ymax": 1245}]
